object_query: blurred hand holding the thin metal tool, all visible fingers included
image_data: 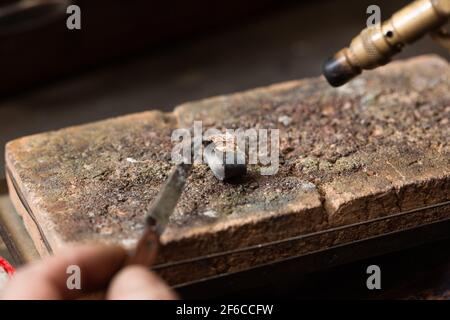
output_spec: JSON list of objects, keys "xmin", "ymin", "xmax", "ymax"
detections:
[{"xmin": 0, "ymin": 245, "xmax": 177, "ymax": 300}]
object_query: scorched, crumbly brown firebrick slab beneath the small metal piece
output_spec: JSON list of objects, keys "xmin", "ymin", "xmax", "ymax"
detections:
[{"xmin": 6, "ymin": 56, "xmax": 450, "ymax": 272}]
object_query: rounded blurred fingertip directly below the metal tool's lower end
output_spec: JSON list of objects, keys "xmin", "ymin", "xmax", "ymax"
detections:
[{"xmin": 106, "ymin": 265, "xmax": 177, "ymax": 300}]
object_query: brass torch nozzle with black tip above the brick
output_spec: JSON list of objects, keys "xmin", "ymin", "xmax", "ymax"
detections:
[{"xmin": 323, "ymin": 0, "xmax": 450, "ymax": 87}]
